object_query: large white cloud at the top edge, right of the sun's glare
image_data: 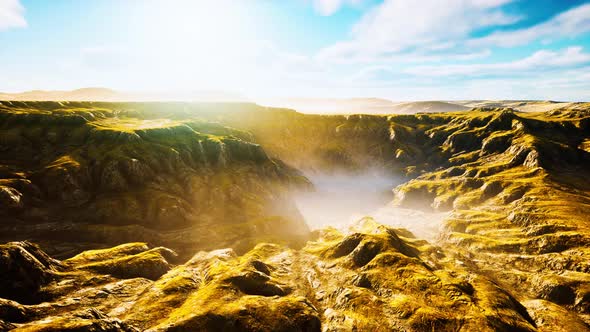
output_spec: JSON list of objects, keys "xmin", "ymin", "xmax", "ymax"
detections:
[{"xmin": 319, "ymin": 0, "xmax": 522, "ymax": 60}]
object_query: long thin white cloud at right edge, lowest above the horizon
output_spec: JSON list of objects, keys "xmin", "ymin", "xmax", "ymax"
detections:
[{"xmin": 405, "ymin": 46, "xmax": 590, "ymax": 77}]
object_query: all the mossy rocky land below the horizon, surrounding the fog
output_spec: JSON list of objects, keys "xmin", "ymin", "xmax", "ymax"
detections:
[{"xmin": 0, "ymin": 102, "xmax": 590, "ymax": 331}]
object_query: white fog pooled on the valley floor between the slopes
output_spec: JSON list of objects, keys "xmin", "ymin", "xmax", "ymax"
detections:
[{"xmin": 295, "ymin": 172, "xmax": 446, "ymax": 241}]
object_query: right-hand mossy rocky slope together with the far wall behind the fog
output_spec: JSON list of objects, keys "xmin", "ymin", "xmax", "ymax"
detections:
[{"xmin": 204, "ymin": 104, "xmax": 590, "ymax": 324}]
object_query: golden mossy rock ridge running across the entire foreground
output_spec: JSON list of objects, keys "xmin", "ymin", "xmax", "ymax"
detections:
[{"xmin": 0, "ymin": 219, "xmax": 560, "ymax": 331}]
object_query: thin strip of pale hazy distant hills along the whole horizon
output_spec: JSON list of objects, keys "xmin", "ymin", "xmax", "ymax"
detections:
[{"xmin": 0, "ymin": 88, "xmax": 583, "ymax": 114}]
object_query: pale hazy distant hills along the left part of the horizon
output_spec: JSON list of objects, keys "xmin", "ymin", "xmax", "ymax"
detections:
[{"xmin": 0, "ymin": 88, "xmax": 247, "ymax": 102}]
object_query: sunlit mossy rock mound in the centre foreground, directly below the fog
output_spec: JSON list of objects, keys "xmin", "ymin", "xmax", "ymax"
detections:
[{"xmin": 300, "ymin": 219, "xmax": 533, "ymax": 331}]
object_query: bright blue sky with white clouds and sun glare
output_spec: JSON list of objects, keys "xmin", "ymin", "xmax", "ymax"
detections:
[{"xmin": 0, "ymin": 0, "xmax": 590, "ymax": 101}]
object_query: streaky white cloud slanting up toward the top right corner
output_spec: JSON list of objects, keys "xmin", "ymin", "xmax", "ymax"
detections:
[{"xmin": 468, "ymin": 4, "xmax": 590, "ymax": 47}]
